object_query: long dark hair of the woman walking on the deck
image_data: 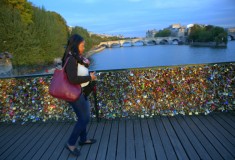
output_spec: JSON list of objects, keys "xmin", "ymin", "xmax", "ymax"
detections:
[{"xmin": 62, "ymin": 34, "xmax": 84, "ymax": 66}]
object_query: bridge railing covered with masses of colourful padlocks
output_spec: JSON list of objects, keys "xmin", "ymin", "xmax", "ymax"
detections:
[{"xmin": 0, "ymin": 62, "xmax": 235, "ymax": 123}]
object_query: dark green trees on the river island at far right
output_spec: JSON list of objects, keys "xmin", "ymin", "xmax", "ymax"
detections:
[{"xmin": 188, "ymin": 25, "xmax": 227, "ymax": 43}]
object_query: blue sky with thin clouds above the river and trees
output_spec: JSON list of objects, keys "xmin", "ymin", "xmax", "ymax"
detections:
[{"xmin": 28, "ymin": 0, "xmax": 235, "ymax": 37}]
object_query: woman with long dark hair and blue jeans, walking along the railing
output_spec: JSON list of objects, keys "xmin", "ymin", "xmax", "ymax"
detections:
[{"xmin": 62, "ymin": 34, "xmax": 96, "ymax": 156}]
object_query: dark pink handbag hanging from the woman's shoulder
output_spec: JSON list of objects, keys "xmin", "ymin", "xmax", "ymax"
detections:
[{"xmin": 49, "ymin": 58, "xmax": 82, "ymax": 102}]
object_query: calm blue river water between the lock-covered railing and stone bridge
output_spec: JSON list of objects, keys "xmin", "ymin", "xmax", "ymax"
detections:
[{"xmin": 90, "ymin": 41, "xmax": 235, "ymax": 70}]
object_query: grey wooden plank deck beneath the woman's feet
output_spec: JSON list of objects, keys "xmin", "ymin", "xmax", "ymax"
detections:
[{"xmin": 0, "ymin": 112, "xmax": 235, "ymax": 160}]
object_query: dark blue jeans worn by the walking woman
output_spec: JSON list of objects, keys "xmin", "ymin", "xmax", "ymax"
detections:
[{"xmin": 68, "ymin": 93, "xmax": 90, "ymax": 146}]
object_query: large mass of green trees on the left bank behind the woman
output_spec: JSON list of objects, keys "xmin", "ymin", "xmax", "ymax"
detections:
[{"xmin": 0, "ymin": 0, "xmax": 68, "ymax": 67}]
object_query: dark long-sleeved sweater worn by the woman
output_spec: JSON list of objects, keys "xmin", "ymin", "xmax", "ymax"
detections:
[{"xmin": 65, "ymin": 56, "xmax": 91, "ymax": 84}]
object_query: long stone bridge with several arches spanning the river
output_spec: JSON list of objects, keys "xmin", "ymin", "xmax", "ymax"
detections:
[{"xmin": 99, "ymin": 37, "xmax": 183, "ymax": 48}]
